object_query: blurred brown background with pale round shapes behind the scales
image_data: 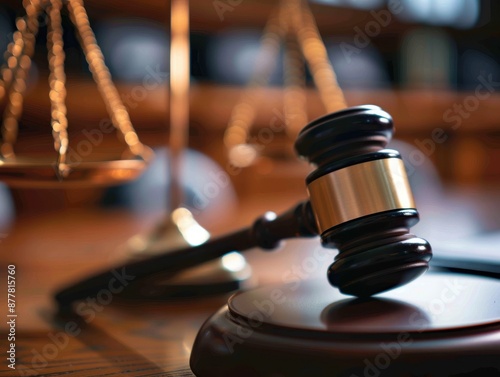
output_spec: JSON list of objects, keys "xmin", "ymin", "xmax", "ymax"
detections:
[{"xmin": 0, "ymin": 0, "xmax": 500, "ymax": 241}]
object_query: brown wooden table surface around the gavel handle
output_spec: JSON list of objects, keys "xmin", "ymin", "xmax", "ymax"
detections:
[{"xmin": 0, "ymin": 195, "xmax": 312, "ymax": 376}]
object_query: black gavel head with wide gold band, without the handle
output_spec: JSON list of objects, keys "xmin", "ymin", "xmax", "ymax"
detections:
[{"xmin": 295, "ymin": 105, "xmax": 432, "ymax": 297}]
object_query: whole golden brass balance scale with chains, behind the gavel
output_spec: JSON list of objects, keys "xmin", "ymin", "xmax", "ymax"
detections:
[{"xmin": 0, "ymin": 0, "xmax": 346, "ymax": 290}]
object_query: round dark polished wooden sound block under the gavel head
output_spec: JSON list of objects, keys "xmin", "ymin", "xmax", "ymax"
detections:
[{"xmin": 190, "ymin": 272, "xmax": 500, "ymax": 377}]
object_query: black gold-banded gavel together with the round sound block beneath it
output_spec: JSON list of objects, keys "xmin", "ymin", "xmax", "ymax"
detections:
[{"xmin": 56, "ymin": 106, "xmax": 500, "ymax": 377}]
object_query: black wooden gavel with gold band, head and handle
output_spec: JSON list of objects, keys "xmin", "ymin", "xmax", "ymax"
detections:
[{"xmin": 55, "ymin": 105, "xmax": 432, "ymax": 307}]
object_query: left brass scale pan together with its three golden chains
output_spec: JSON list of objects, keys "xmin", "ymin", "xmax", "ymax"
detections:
[{"xmin": 0, "ymin": 0, "xmax": 153, "ymax": 187}]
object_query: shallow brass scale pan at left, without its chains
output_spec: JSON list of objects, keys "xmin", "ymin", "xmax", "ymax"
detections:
[{"xmin": 0, "ymin": 151, "xmax": 152, "ymax": 189}]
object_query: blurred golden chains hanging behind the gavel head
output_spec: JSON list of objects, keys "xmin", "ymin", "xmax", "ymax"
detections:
[{"xmin": 224, "ymin": 0, "xmax": 347, "ymax": 167}]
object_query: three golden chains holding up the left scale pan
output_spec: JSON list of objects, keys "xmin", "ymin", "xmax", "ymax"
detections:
[{"xmin": 0, "ymin": 0, "xmax": 147, "ymax": 162}]
